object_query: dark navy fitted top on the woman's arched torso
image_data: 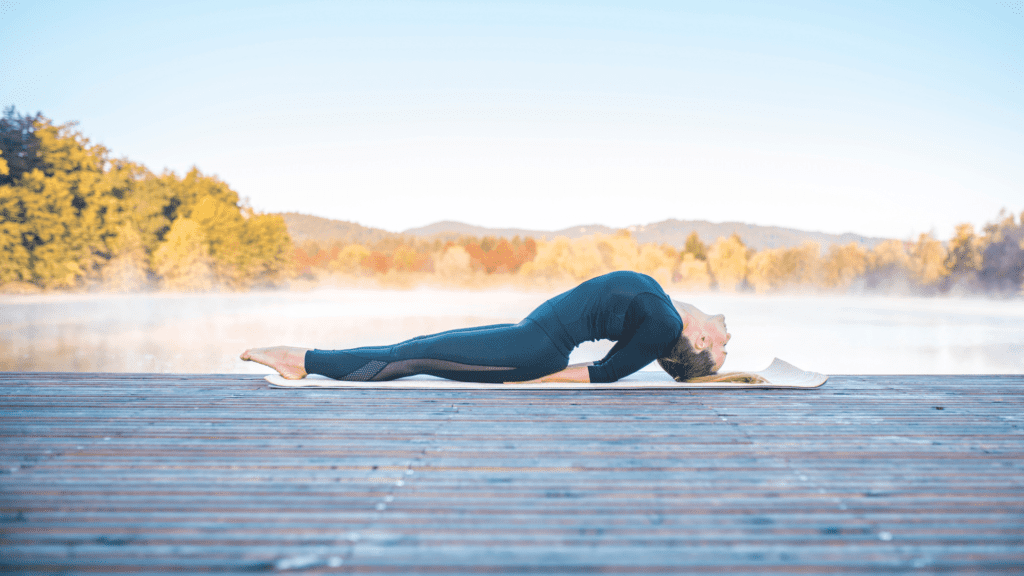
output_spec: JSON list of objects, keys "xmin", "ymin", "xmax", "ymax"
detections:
[{"xmin": 548, "ymin": 272, "xmax": 683, "ymax": 382}]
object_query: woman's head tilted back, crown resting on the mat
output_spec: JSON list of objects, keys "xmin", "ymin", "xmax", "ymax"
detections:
[{"xmin": 657, "ymin": 300, "xmax": 732, "ymax": 381}]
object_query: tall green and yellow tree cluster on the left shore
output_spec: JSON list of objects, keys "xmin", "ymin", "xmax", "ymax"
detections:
[{"xmin": 0, "ymin": 107, "xmax": 294, "ymax": 291}]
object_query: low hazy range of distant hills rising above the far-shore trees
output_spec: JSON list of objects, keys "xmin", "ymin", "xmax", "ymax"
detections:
[{"xmin": 281, "ymin": 212, "xmax": 886, "ymax": 250}]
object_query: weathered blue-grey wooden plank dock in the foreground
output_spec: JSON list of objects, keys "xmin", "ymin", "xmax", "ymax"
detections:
[{"xmin": 0, "ymin": 373, "xmax": 1024, "ymax": 574}]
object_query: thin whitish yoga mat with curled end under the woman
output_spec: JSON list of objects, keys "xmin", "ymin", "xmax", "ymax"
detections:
[{"xmin": 266, "ymin": 358, "xmax": 828, "ymax": 390}]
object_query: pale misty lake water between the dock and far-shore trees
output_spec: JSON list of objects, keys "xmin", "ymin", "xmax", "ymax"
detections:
[{"xmin": 0, "ymin": 290, "xmax": 1024, "ymax": 374}]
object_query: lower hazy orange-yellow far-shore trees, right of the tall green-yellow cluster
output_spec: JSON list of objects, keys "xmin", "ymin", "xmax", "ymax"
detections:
[{"xmin": 295, "ymin": 212, "xmax": 1024, "ymax": 295}]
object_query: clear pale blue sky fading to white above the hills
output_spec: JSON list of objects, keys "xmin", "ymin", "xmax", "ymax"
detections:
[{"xmin": 0, "ymin": 0, "xmax": 1024, "ymax": 239}]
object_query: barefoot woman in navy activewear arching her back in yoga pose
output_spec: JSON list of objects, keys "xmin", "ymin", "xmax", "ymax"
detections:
[{"xmin": 241, "ymin": 272, "xmax": 731, "ymax": 382}]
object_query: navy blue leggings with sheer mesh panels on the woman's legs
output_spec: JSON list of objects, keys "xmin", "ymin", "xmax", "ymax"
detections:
[{"xmin": 305, "ymin": 318, "xmax": 568, "ymax": 383}]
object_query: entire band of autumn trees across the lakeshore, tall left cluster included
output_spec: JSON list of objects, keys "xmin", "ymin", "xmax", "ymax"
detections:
[{"xmin": 0, "ymin": 108, "xmax": 1024, "ymax": 296}]
